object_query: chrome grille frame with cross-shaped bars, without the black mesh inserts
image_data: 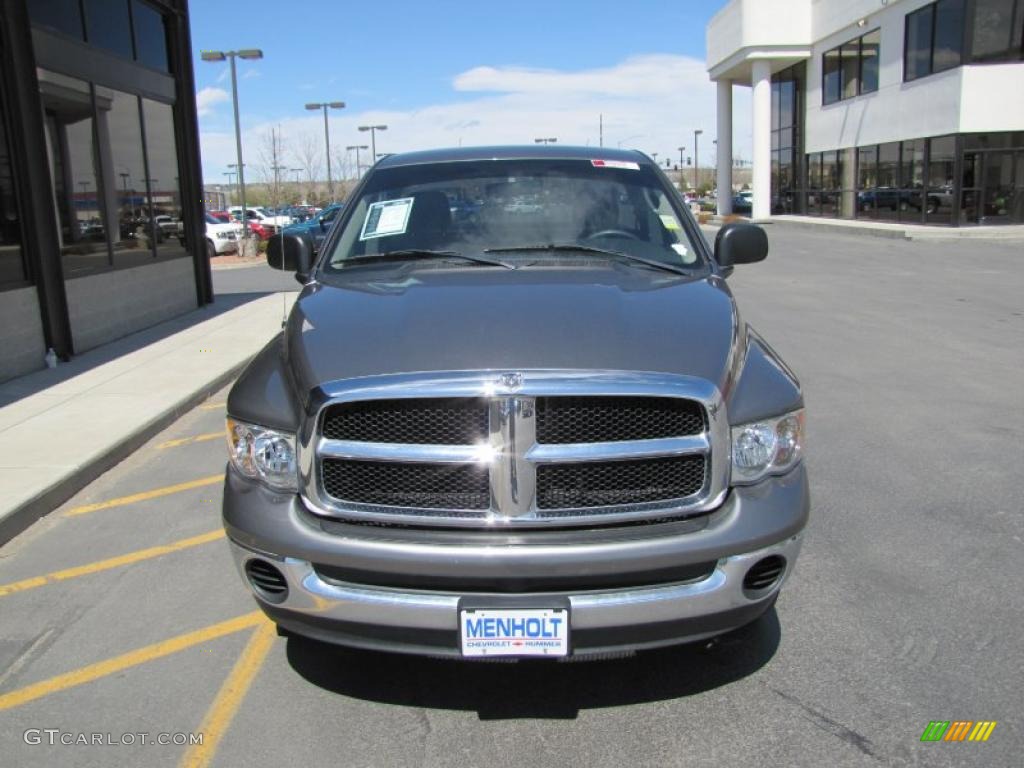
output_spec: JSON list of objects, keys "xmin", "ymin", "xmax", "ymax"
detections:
[{"xmin": 298, "ymin": 370, "xmax": 729, "ymax": 527}]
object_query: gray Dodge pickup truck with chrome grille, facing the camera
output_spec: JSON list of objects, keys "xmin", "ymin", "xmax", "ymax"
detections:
[{"xmin": 223, "ymin": 146, "xmax": 809, "ymax": 658}]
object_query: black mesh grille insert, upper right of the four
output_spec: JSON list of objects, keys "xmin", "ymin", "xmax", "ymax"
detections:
[{"xmin": 537, "ymin": 397, "xmax": 705, "ymax": 443}]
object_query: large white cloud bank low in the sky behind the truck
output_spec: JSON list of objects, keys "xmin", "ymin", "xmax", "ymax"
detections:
[{"xmin": 195, "ymin": 54, "xmax": 751, "ymax": 182}]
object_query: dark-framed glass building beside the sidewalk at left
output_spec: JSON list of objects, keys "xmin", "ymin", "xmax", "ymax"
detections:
[{"xmin": 0, "ymin": 0, "xmax": 212, "ymax": 380}]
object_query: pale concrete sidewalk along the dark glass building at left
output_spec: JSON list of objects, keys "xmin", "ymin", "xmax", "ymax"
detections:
[{"xmin": 0, "ymin": 292, "xmax": 297, "ymax": 544}]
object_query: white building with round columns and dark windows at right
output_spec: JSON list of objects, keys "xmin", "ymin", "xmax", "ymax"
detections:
[{"xmin": 708, "ymin": 0, "xmax": 1024, "ymax": 226}]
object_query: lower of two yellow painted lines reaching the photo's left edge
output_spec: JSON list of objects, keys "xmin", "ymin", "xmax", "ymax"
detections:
[{"xmin": 0, "ymin": 610, "xmax": 265, "ymax": 711}]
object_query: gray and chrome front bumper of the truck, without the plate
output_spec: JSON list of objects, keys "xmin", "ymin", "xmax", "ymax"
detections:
[{"xmin": 224, "ymin": 465, "xmax": 809, "ymax": 655}]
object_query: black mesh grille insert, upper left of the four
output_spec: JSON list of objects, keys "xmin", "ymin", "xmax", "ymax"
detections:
[{"xmin": 324, "ymin": 397, "xmax": 487, "ymax": 445}]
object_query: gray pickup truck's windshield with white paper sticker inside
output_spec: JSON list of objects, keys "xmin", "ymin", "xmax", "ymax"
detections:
[{"xmin": 325, "ymin": 159, "xmax": 700, "ymax": 272}]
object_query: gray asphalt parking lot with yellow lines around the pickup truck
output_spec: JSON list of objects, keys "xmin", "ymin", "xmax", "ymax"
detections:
[{"xmin": 0, "ymin": 226, "xmax": 1024, "ymax": 766}]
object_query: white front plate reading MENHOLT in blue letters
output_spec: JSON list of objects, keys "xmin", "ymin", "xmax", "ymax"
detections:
[{"xmin": 459, "ymin": 608, "xmax": 569, "ymax": 656}]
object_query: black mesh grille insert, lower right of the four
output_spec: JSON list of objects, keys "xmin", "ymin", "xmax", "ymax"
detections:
[{"xmin": 537, "ymin": 456, "xmax": 705, "ymax": 509}]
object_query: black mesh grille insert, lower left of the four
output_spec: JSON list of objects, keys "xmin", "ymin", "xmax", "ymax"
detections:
[{"xmin": 323, "ymin": 459, "xmax": 490, "ymax": 510}]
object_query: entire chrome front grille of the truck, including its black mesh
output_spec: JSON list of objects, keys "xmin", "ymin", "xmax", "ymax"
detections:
[{"xmin": 299, "ymin": 371, "xmax": 728, "ymax": 526}]
